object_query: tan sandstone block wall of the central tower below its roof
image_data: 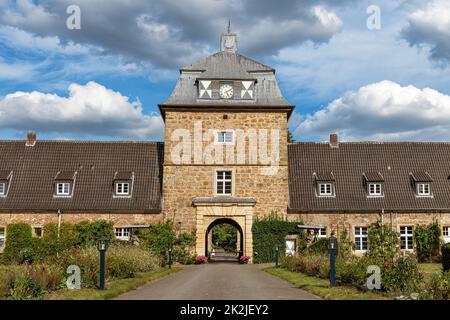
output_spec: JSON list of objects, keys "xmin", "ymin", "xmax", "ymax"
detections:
[{"xmin": 163, "ymin": 112, "xmax": 288, "ymax": 230}]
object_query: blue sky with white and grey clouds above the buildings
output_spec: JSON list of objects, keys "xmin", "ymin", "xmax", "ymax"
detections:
[{"xmin": 0, "ymin": 0, "xmax": 450, "ymax": 141}]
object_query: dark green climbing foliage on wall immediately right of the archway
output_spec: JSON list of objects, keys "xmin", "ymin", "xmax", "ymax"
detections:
[{"xmin": 252, "ymin": 213, "xmax": 301, "ymax": 263}]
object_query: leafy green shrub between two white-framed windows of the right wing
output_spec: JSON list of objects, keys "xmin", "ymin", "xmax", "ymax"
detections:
[{"xmin": 367, "ymin": 220, "xmax": 400, "ymax": 263}]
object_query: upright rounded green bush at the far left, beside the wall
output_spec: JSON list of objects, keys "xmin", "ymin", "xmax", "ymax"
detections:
[{"xmin": 3, "ymin": 223, "xmax": 34, "ymax": 263}]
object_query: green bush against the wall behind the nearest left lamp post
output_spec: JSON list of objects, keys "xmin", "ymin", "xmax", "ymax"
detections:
[{"xmin": 74, "ymin": 220, "xmax": 115, "ymax": 247}]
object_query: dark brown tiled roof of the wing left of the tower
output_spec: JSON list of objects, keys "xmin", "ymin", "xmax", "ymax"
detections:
[{"xmin": 0, "ymin": 140, "xmax": 163, "ymax": 213}]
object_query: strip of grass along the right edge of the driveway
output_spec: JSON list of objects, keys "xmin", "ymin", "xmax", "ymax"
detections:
[{"xmin": 264, "ymin": 268, "xmax": 389, "ymax": 300}]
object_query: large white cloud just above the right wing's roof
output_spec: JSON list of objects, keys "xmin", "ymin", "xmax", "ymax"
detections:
[{"xmin": 296, "ymin": 80, "xmax": 450, "ymax": 141}]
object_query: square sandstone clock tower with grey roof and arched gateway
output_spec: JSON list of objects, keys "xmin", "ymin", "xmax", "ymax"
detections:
[{"xmin": 159, "ymin": 28, "xmax": 294, "ymax": 257}]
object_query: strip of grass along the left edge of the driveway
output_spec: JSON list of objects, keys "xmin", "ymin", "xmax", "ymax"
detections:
[{"xmin": 47, "ymin": 268, "xmax": 181, "ymax": 300}]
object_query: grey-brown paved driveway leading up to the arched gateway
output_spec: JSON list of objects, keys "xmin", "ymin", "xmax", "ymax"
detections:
[{"xmin": 116, "ymin": 263, "xmax": 319, "ymax": 300}]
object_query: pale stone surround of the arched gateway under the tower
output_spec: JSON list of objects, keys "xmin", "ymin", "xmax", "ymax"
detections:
[{"xmin": 192, "ymin": 198, "xmax": 256, "ymax": 262}]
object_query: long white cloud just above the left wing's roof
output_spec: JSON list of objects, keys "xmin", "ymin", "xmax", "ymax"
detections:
[{"xmin": 0, "ymin": 82, "xmax": 164, "ymax": 139}]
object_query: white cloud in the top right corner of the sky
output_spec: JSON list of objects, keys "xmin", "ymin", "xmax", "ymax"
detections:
[{"xmin": 402, "ymin": 0, "xmax": 450, "ymax": 63}]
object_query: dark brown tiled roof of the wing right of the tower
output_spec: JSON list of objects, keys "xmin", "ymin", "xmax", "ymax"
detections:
[{"xmin": 288, "ymin": 142, "xmax": 450, "ymax": 212}]
